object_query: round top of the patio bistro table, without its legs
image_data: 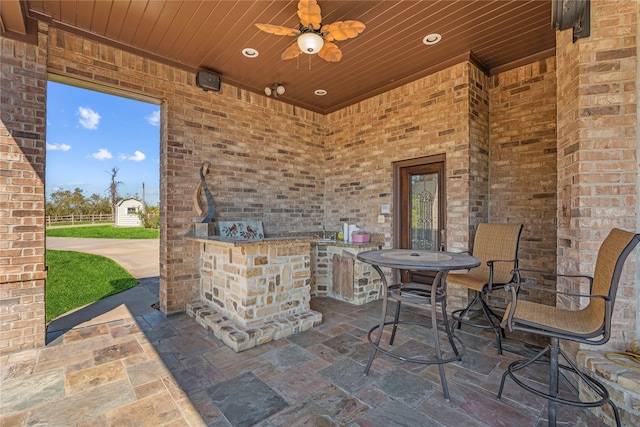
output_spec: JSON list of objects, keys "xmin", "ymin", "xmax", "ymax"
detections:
[{"xmin": 358, "ymin": 249, "xmax": 480, "ymax": 271}]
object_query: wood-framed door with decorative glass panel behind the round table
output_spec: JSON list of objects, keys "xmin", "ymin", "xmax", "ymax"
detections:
[{"xmin": 394, "ymin": 155, "xmax": 446, "ymax": 283}]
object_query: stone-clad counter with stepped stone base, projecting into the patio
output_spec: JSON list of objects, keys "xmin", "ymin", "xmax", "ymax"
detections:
[{"xmin": 186, "ymin": 236, "xmax": 322, "ymax": 352}]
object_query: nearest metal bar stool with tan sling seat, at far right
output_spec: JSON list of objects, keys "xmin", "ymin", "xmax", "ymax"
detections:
[{"xmin": 498, "ymin": 228, "xmax": 640, "ymax": 427}]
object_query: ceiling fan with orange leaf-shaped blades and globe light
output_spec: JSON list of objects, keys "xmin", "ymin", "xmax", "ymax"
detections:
[{"xmin": 256, "ymin": 0, "xmax": 366, "ymax": 62}]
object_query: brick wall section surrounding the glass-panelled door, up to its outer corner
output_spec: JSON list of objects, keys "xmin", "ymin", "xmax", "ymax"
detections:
[{"xmin": 325, "ymin": 62, "xmax": 487, "ymax": 306}]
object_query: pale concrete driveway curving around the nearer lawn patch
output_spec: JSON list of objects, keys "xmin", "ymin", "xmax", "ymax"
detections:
[{"xmin": 46, "ymin": 237, "xmax": 160, "ymax": 343}]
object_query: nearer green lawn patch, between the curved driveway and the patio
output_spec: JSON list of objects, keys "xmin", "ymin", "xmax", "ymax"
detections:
[{"xmin": 45, "ymin": 251, "xmax": 138, "ymax": 323}]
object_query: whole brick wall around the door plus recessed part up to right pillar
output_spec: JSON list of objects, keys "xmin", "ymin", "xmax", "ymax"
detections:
[{"xmin": 325, "ymin": 58, "xmax": 556, "ymax": 307}]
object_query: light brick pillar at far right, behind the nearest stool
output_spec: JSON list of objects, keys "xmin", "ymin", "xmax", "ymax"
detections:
[{"xmin": 556, "ymin": 0, "xmax": 640, "ymax": 349}]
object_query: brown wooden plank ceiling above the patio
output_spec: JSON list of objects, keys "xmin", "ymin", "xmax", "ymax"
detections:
[{"xmin": 2, "ymin": 0, "xmax": 555, "ymax": 113}]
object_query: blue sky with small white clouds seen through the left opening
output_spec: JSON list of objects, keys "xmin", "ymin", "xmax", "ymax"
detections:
[{"xmin": 46, "ymin": 82, "xmax": 160, "ymax": 206}]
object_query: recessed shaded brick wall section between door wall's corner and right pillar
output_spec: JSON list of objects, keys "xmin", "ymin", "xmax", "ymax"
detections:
[{"xmin": 489, "ymin": 58, "xmax": 557, "ymax": 307}]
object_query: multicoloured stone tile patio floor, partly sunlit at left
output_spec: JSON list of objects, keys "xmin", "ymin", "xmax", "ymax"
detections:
[{"xmin": 0, "ymin": 298, "xmax": 603, "ymax": 427}]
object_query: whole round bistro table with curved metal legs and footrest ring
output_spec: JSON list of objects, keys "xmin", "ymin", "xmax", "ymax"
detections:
[{"xmin": 358, "ymin": 249, "xmax": 480, "ymax": 401}]
